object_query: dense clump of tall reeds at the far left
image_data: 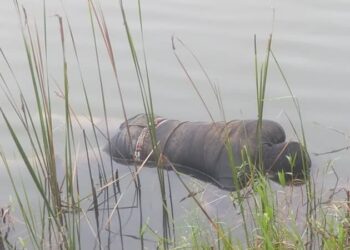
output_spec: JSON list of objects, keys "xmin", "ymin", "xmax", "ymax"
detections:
[{"xmin": 1, "ymin": 1, "xmax": 90, "ymax": 249}]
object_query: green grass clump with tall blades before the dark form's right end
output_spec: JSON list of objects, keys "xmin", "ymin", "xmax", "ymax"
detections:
[{"xmin": 249, "ymin": 32, "xmax": 315, "ymax": 249}]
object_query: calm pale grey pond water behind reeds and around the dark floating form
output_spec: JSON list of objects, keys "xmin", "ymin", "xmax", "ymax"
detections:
[{"xmin": 0, "ymin": 0, "xmax": 350, "ymax": 246}]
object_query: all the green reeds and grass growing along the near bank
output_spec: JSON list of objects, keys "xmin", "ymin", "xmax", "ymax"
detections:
[{"xmin": 0, "ymin": 0, "xmax": 349, "ymax": 249}]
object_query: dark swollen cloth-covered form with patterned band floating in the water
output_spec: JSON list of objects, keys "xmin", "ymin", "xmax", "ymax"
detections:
[{"xmin": 106, "ymin": 114, "xmax": 311, "ymax": 190}]
